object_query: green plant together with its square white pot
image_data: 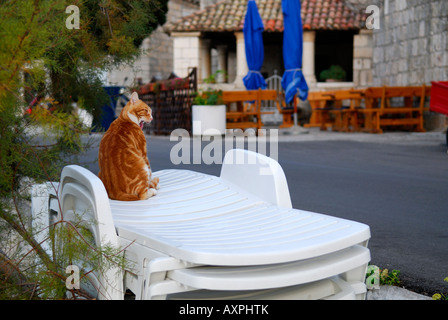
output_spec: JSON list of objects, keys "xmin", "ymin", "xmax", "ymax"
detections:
[{"xmin": 191, "ymin": 70, "xmax": 226, "ymax": 135}]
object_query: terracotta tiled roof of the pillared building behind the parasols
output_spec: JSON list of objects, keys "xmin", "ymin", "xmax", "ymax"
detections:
[{"xmin": 165, "ymin": 0, "xmax": 366, "ymax": 32}]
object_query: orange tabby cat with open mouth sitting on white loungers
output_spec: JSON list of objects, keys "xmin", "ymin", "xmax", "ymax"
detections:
[{"xmin": 98, "ymin": 92, "xmax": 159, "ymax": 201}]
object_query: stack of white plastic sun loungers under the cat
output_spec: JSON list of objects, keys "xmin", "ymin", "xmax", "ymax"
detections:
[{"xmin": 32, "ymin": 150, "xmax": 370, "ymax": 299}]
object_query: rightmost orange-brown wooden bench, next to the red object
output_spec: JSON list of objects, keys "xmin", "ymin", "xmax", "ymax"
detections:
[{"xmin": 359, "ymin": 85, "xmax": 430, "ymax": 133}]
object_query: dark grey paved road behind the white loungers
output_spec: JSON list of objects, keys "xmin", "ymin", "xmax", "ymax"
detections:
[{"xmin": 80, "ymin": 131, "xmax": 448, "ymax": 294}]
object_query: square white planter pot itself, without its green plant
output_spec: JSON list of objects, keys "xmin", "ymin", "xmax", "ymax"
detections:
[{"xmin": 191, "ymin": 105, "xmax": 226, "ymax": 136}]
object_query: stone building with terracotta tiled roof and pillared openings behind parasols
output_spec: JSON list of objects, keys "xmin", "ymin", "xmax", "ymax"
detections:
[{"xmin": 165, "ymin": 0, "xmax": 372, "ymax": 89}]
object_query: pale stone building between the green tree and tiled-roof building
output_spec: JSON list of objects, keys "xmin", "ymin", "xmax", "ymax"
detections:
[{"xmin": 106, "ymin": 0, "xmax": 199, "ymax": 86}]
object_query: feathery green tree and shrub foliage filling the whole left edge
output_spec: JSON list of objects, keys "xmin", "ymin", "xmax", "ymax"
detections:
[{"xmin": 0, "ymin": 0, "xmax": 168, "ymax": 299}]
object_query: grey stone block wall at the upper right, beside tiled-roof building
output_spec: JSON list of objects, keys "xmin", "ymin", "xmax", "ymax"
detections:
[{"xmin": 372, "ymin": 0, "xmax": 448, "ymax": 86}]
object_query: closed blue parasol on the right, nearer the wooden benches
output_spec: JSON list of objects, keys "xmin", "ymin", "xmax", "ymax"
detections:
[{"xmin": 282, "ymin": 0, "xmax": 308, "ymax": 103}]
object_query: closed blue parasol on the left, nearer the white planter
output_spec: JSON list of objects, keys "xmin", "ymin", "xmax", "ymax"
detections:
[{"xmin": 243, "ymin": 0, "xmax": 267, "ymax": 90}]
